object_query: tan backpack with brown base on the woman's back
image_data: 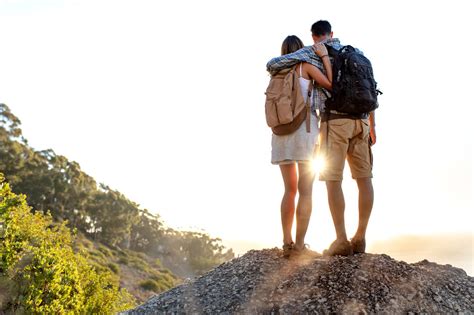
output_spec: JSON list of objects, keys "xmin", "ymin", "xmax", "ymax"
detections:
[{"xmin": 265, "ymin": 66, "xmax": 313, "ymax": 136}]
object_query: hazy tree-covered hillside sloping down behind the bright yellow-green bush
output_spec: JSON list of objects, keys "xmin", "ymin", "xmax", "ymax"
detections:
[{"xmin": 0, "ymin": 103, "xmax": 234, "ymax": 312}]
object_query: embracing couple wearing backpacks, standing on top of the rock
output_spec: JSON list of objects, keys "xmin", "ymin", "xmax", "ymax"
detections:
[{"xmin": 265, "ymin": 20, "xmax": 379, "ymax": 257}]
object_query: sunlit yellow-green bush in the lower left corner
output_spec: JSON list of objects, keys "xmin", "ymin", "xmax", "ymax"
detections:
[{"xmin": 0, "ymin": 174, "xmax": 134, "ymax": 314}]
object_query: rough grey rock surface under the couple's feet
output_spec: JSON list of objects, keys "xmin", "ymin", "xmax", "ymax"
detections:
[{"xmin": 124, "ymin": 248, "xmax": 474, "ymax": 314}]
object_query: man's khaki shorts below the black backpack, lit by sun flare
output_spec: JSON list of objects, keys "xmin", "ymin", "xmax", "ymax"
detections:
[{"xmin": 319, "ymin": 118, "xmax": 373, "ymax": 181}]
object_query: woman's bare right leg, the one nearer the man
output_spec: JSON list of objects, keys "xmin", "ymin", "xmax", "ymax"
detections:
[{"xmin": 295, "ymin": 163, "xmax": 314, "ymax": 249}]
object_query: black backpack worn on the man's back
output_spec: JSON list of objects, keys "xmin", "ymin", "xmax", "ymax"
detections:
[{"xmin": 325, "ymin": 45, "xmax": 382, "ymax": 116}]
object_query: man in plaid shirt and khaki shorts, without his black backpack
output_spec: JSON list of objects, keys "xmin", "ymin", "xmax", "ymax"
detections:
[{"xmin": 267, "ymin": 20, "xmax": 376, "ymax": 256}]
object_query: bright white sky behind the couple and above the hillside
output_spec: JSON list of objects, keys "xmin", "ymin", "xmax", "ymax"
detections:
[{"xmin": 0, "ymin": 0, "xmax": 474, "ymax": 274}]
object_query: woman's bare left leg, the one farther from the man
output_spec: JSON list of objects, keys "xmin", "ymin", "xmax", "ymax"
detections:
[{"xmin": 280, "ymin": 163, "xmax": 298, "ymax": 244}]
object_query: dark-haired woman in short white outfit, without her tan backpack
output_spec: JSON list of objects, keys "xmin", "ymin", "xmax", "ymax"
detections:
[{"xmin": 272, "ymin": 35, "xmax": 332, "ymax": 257}]
